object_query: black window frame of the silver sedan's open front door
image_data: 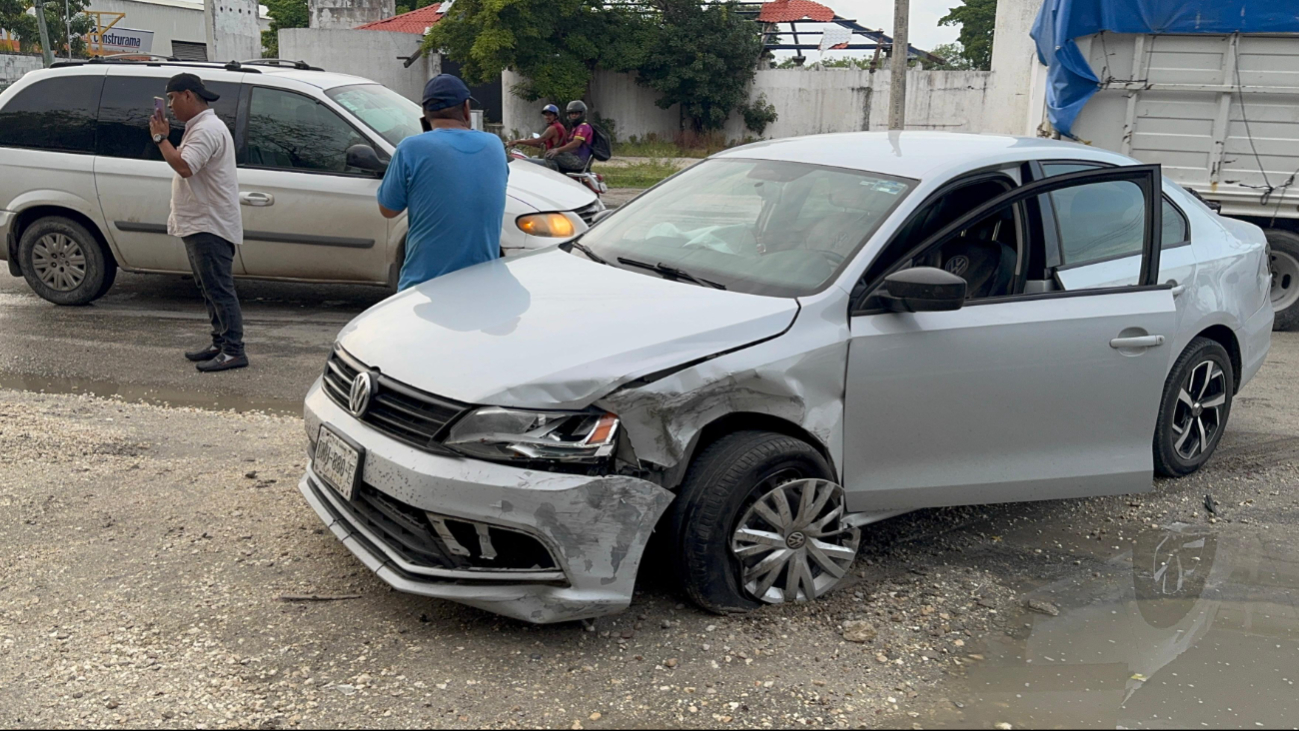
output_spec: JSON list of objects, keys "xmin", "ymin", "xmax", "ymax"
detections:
[{"xmin": 851, "ymin": 165, "xmax": 1172, "ymax": 317}]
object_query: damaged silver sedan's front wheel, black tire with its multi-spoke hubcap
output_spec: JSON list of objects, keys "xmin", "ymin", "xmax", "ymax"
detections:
[{"xmin": 672, "ymin": 431, "xmax": 860, "ymax": 614}]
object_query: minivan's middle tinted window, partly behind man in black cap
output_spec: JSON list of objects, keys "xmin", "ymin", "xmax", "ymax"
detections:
[{"xmin": 96, "ymin": 77, "xmax": 239, "ymax": 161}]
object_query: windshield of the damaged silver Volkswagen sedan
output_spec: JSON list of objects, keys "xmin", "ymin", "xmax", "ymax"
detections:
[{"xmin": 574, "ymin": 158, "xmax": 914, "ymax": 297}]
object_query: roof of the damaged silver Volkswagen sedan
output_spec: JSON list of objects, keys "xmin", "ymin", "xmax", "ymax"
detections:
[{"xmin": 713, "ymin": 130, "xmax": 1134, "ymax": 180}]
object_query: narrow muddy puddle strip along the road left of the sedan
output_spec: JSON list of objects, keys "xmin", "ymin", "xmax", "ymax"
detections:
[{"xmin": 0, "ymin": 373, "xmax": 305, "ymax": 417}]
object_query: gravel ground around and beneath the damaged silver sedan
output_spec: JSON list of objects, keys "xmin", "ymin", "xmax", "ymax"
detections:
[{"xmin": 0, "ymin": 335, "xmax": 1299, "ymax": 728}]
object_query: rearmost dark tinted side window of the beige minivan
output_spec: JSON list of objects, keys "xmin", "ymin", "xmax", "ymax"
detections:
[{"xmin": 0, "ymin": 77, "xmax": 104, "ymax": 153}]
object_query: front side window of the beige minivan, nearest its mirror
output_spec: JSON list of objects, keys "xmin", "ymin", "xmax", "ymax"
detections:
[{"xmin": 247, "ymin": 87, "xmax": 369, "ymax": 173}]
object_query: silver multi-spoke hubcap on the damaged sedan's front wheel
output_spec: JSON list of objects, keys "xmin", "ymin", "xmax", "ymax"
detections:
[{"xmin": 731, "ymin": 479, "xmax": 861, "ymax": 604}]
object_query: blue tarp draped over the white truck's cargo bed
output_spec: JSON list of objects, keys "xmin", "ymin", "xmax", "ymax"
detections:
[{"xmin": 1030, "ymin": 0, "xmax": 1299, "ymax": 135}]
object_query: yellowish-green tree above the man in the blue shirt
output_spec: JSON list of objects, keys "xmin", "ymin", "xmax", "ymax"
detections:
[{"xmin": 425, "ymin": 0, "xmax": 640, "ymax": 103}]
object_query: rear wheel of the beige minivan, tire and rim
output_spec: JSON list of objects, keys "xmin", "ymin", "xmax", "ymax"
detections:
[{"xmin": 18, "ymin": 216, "xmax": 117, "ymax": 305}]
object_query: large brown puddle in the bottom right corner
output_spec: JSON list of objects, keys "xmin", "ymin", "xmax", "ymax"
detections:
[{"xmin": 926, "ymin": 525, "xmax": 1299, "ymax": 728}]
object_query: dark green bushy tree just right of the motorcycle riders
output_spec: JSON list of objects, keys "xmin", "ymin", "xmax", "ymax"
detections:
[{"xmin": 622, "ymin": 0, "xmax": 763, "ymax": 132}]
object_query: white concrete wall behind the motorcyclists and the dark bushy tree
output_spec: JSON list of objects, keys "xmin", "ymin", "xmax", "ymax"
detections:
[{"xmin": 501, "ymin": 69, "xmax": 991, "ymax": 146}]
